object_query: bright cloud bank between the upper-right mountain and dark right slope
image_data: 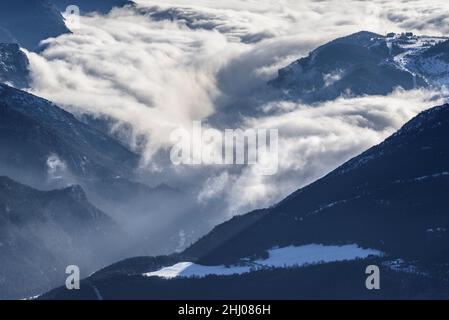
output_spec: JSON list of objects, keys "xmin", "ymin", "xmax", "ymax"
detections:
[{"xmin": 225, "ymin": 90, "xmax": 447, "ymax": 212}]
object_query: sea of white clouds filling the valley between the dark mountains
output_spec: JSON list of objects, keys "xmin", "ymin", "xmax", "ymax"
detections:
[{"xmin": 27, "ymin": 0, "xmax": 449, "ymax": 225}]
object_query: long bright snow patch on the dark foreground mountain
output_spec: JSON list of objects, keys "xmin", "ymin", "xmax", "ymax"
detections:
[{"xmin": 144, "ymin": 244, "xmax": 383, "ymax": 279}]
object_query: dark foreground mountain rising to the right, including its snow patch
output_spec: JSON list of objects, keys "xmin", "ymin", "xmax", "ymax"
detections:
[{"xmin": 40, "ymin": 105, "xmax": 449, "ymax": 299}]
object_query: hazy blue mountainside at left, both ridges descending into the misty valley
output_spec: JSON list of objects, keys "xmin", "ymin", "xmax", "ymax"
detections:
[{"xmin": 0, "ymin": 83, "xmax": 201, "ymax": 299}]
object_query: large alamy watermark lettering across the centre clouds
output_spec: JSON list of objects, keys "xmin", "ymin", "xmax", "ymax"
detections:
[{"xmin": 170, "ymin": 121, "xmax": 279, "ymax": 176}]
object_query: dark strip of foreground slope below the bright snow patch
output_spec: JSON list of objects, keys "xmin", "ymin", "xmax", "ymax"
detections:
[{"xmin": 39, "ymin": 259, "xmax": 449, "ymax": 301}]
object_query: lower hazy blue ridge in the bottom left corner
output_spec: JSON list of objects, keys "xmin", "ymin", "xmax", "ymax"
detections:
[{"xmin": 0, "ymin": 177, "xmax": 120, "ymax": 299}]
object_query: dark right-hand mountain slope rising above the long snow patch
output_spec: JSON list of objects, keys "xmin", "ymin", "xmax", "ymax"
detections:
[{"xmin": 185, "ymin": 105, "xmax": 449, "ymax": 263}]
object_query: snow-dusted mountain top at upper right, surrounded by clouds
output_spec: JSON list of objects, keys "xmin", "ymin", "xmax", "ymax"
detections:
[{"xmin": 269, "ymin": 31, "xmax": 449, "ymax": 102}]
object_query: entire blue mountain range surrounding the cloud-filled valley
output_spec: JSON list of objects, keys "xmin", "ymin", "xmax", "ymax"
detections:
[{"xmin": 0, "ymin": 0, "xmax": 449, "ymax": 300}]
